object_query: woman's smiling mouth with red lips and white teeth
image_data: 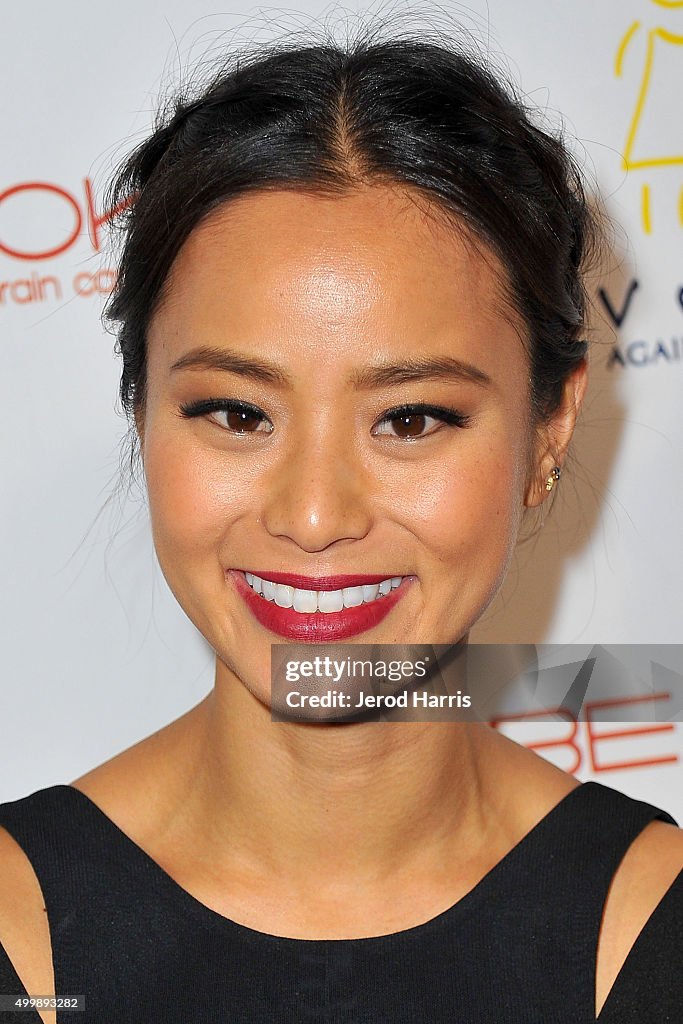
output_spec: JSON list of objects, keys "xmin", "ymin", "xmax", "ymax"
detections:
[{"xmin": 227, "ymin": 569, "xmax": 415, "ymax": 643}]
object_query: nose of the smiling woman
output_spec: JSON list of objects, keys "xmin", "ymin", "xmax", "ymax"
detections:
[{"xmin": 261, "ymin": 440, "xmax": 372, "ymax": 551}]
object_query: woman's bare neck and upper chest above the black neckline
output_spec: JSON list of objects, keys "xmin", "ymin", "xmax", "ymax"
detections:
[{"xmin": 75, "ymin": 655, "xmax": 577, "ymax": 938}]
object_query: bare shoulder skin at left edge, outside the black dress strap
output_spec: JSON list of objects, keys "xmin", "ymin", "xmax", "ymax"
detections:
[{"xmin": 0, "ymin": 826, "xmax": 55, "ymax": 1024}]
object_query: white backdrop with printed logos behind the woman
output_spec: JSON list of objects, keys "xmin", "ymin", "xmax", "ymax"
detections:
[{"xmin": 0, "ymin": 0, "xmax": 683, "ymax": 820}]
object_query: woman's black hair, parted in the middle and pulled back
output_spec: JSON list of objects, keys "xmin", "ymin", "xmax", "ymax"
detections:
[{"xmin": 106, "ymin": 18, "xmax": 598, "ymax": 452}]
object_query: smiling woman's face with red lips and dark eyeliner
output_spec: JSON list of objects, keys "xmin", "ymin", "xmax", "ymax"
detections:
[{"xmin": 138, "ymin": 187, "xmax": 557, "ymax": 702}]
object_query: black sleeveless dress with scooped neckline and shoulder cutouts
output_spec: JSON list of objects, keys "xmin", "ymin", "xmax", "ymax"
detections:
[{"xmin": 0, "ymin": 782, "xmax": 683, "ymax": 1024}]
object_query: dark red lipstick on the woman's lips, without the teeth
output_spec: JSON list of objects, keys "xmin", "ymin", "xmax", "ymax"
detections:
[{"xmin": 226, "ymin": 569, "xmax": 416, "ymax": 643}]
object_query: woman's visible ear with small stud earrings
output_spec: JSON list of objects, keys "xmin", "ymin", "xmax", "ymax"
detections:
[{"xmin": 524, "ymin": 359, "xmax": 588, "ymax": 508}]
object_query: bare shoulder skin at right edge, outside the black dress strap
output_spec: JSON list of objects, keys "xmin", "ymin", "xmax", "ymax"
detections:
[{"xmin": 596, "ymin": 821, "xmax": 683, "ymax": 1012}]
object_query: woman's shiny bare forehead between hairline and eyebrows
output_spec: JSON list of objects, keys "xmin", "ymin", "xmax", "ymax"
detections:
[{"xmin": 152, "ymin": 186, "xmax": 520, "ymax": 334}]
